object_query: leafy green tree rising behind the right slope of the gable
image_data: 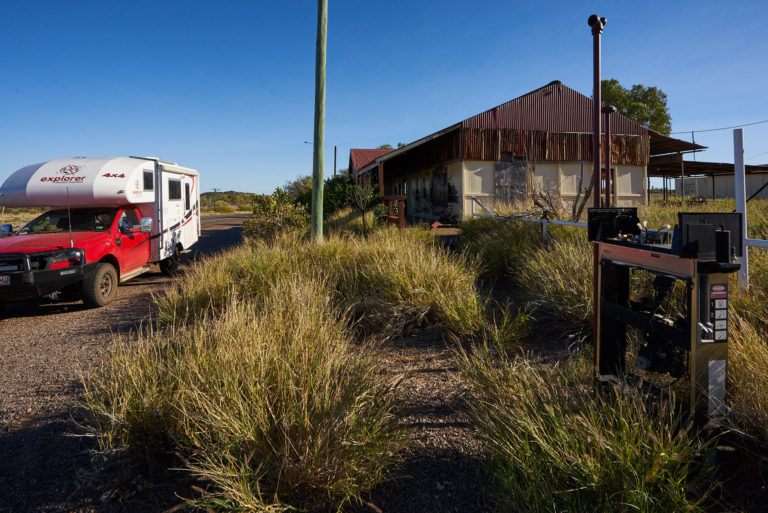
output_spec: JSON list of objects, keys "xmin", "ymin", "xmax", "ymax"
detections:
[{"xmin": 600, "ymin": 78, "xmax": 672, "ymax": 135}]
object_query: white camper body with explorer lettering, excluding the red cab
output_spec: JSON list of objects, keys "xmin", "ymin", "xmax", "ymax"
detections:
[{"xmin": 0, "ymin": 157, "xmax": 200, "ymax": 262}]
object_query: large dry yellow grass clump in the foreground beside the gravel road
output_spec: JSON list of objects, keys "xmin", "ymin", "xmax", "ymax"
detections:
[{"xmin": 85, "ymin": 276, "xmax": 402, "ymax": 511}]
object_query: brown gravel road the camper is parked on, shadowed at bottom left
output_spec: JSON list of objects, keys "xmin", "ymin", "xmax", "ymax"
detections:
[{"xmin": 0, "ymin": 215, "xmax": 245, "ymax": 511}]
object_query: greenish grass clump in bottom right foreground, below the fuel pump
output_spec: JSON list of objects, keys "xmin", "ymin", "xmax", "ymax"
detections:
[{"xmin": 462, "ymin": 345, "xmax": 701, "ymax": 513}]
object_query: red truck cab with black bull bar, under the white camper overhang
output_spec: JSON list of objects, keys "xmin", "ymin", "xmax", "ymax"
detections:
[{"xmin": 0, "ymin": 205, "xmax": 151, "ymax": 308}]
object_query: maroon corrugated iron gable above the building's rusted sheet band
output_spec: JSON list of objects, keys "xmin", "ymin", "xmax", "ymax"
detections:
[{"xmin": 462, "ymin": 80, "xmax": 648, "ymax": 135}]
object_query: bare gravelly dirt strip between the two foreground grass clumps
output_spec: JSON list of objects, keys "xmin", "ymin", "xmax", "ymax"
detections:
[{"xmin": 350, "ymin": 335, "xmax": 487, "ymax": 513}]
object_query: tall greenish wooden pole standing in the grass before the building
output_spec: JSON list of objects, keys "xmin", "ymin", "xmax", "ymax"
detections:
[{"xmin": 312, "ymin": 0, "xmax": 328, "ymax": 242}]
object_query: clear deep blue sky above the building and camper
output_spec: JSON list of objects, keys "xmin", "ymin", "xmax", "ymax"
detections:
[{"xmin": 0, "ymin": 0, "xmax": 768, "ymax": 192}]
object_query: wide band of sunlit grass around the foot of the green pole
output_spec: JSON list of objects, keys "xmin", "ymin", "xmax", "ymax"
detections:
[{"xmin": 157, "ymin": 229, "xmax": 485, "ymax": 336}]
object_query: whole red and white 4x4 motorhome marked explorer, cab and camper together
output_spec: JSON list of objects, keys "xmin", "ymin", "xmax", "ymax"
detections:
[{"xmin": 0, "ymin": 157, "xmax": 200, "ymax": 308}]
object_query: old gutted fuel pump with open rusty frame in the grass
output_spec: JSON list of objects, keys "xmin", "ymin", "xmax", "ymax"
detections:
[{"xmin": 588, "ymin": 208, "xmax": 743, "ymax": 421}]
